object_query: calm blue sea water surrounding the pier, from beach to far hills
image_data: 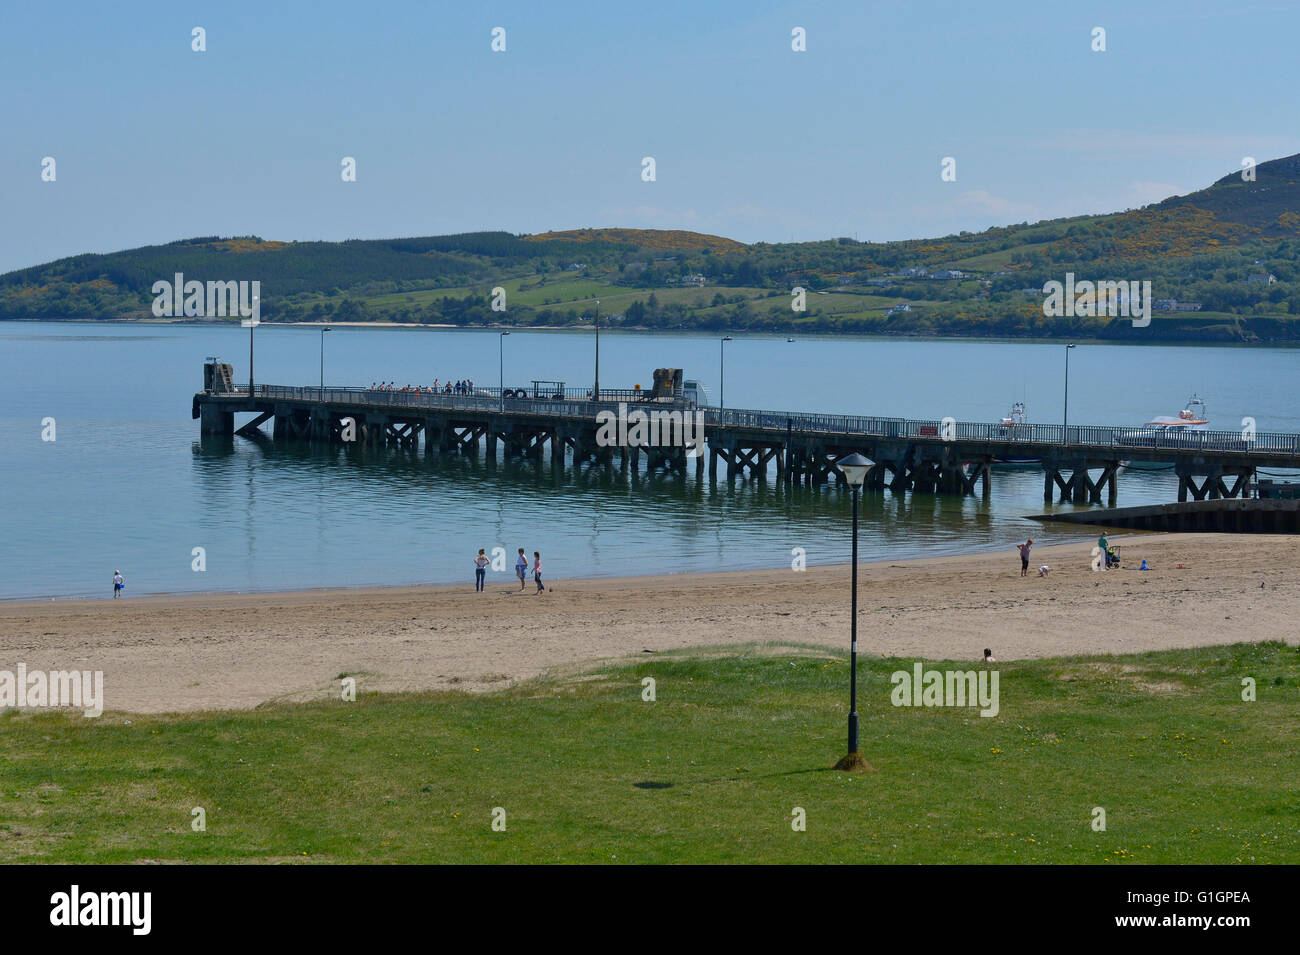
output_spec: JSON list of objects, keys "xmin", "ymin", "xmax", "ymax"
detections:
[{"xmin": 0, "ymin": 322, "xmax": 1300, "ymax": 598}]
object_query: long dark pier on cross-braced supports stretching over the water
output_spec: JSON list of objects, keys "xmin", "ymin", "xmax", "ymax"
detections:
[{"xmin": 192, "ymin": 385, "xmax": 1300, "ymax": 505}]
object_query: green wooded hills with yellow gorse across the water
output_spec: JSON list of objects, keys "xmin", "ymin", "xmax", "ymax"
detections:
[{"xmin": 0, "ymin": 156, "xmax": 1300, "ymax": 343}]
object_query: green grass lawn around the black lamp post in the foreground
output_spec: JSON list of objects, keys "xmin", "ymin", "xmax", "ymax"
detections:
[{"xmin": 0, "ymin": 643, "xmax": 1300, "ymax": 864}]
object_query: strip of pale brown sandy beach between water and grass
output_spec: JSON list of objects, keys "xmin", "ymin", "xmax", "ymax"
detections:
[{"xmin": 0, "ymin": 534, "xmax": 1300, "ymax": 712}]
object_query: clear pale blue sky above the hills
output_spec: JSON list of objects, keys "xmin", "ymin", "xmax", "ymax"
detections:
[{"xmin": 0, "ymin": 0, "xmax": 1300, "ymax": 272}]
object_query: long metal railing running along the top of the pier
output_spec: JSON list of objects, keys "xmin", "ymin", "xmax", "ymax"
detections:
[{"xmin": 228, "ymin": 385, "xmax": 1300, "ymax": 456}]
